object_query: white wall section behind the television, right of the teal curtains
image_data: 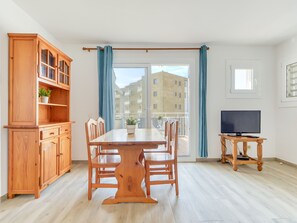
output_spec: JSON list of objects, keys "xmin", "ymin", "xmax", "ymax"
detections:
[{"xmin": 207, "ymin": 46, "xmax": 276, "ymax": 157}]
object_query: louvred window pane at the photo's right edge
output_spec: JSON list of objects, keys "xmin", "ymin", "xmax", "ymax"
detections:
[{"xmin": 286, "ymin": 63, "xmax": 297, "ymax": 98}]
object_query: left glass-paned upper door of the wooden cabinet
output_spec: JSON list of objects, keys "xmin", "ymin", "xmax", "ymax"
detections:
[{"xmin": 39, "ymin": 43, "xmax": 57, "ymax": 82}]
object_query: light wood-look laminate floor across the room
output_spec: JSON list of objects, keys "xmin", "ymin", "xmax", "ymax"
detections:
[{"xmin": 0, "ymin": 161, "xmax": 297, "ymax": 223}]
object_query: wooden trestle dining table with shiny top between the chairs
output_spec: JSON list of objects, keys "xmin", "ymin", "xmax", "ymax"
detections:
[{"xmin": 90, "ymin": 129, "xmax": 166, "ymax": 204}]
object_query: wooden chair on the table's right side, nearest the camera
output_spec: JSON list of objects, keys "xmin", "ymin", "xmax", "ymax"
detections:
[{"xmin": 145, "ymin": 121, "xmax": 179, "ymax": 196}]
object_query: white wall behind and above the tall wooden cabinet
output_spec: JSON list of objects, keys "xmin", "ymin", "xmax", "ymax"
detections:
[{"xmin": 0, "ymin": 0, "xmax": 60, "ymax": 196}]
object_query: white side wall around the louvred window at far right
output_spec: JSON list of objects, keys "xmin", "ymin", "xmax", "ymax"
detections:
[{"xmin": 276, "ymin": 36, "xmax": 297, "ymax": 164}]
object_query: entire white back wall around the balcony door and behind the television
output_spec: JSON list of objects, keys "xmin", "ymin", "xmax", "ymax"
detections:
[{"xmin": 64, "ymin": 44, "xmax": 276, "ymax": 160}]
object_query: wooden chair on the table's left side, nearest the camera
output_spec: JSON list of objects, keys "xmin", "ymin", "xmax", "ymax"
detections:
[{"xmin": 85, "ymin": 119, "xmax": 121, "ymax": 200}]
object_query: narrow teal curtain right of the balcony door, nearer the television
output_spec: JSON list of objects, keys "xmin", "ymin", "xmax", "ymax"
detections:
[{"xmin": 199, "ymin": 45, "xmax": 208, "ymax": 157}]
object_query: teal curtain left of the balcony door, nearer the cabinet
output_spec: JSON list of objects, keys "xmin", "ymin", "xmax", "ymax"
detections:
[{"xmin": 97, "ymin": 46, "xmax": 114, "ymax": 131}]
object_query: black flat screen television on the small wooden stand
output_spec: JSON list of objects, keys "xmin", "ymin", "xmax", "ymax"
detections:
[{"xmin": 221, "ymin": 110, "xmax": 261, "ymax": 136}]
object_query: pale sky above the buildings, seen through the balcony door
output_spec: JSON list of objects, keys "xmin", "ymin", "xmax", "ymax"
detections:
[{"xmin": 113, "ymin": 65, "xmax": 189, "ymax": 88}]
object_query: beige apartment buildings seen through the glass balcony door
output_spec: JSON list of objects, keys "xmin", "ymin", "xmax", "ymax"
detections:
[{"xmin": 115, "ymin": 71, "xmax": 188, "ymax": 118}]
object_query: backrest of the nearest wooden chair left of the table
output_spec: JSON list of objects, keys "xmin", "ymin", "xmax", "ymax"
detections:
[{"xmin": 85, "ymin": 118, "xmax": 99, "ymax": 162}]
